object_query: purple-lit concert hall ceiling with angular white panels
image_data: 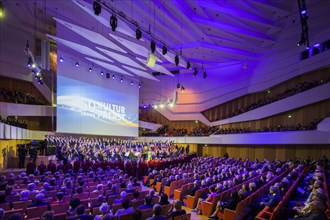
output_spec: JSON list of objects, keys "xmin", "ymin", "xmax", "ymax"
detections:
[{"xmin": 4, "ymin": 0, "xmax": 297, "ymax": 81}]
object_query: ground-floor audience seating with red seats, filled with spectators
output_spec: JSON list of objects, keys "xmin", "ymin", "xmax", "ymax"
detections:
[{"xmin": 0, "ymin": 157, "xmax": 330, "ymax": 220}]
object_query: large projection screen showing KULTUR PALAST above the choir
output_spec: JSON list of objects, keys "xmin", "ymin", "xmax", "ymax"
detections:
[{"xmin": 56, "ymin": 53, "xmax": 139, "ymax": 137}]
